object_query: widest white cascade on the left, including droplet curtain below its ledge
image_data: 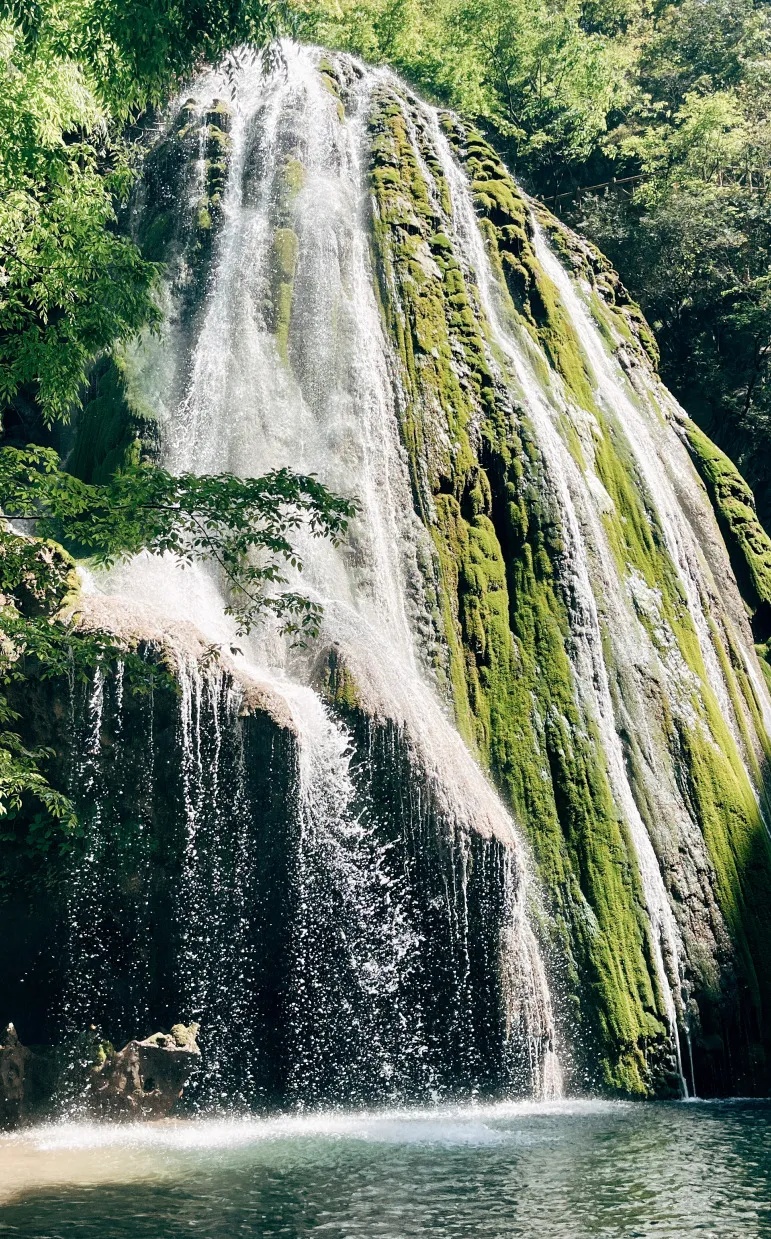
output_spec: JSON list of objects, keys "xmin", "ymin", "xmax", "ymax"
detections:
[{"xmin": 66, "ymin": 47, "xmax": 562, "ymax": 1104}]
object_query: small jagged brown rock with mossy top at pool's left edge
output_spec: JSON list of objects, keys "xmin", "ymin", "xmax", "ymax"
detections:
[{"xmin": 88, "ymin": 1023, "xmax": 201, "ymax": 1119}]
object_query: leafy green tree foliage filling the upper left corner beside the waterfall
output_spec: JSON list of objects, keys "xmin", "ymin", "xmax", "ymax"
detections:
[{"xmin": 0, "ymin": 0, "xmax": 288, "ymax": 424}]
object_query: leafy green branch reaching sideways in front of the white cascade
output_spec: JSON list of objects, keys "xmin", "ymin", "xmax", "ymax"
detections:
[{"xmin": 0, "ymin": 447, "xmax": 355, "ymax": 636}]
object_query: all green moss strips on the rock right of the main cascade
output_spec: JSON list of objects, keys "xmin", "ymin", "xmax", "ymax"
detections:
[{"xmin": 371, "ymin": 84, "xmax": 771, "ymax": 1095}]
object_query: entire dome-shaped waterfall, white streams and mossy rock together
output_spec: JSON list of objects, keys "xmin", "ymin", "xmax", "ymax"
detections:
[{"xmin": 46, "ymin": 46, "xmax": 771, "ymax": 1105}]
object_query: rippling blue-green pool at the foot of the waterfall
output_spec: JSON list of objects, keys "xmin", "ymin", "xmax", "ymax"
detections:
[{"xmin": 0, "ymin": 1101, "xmax": 771, "ymax": 1239}]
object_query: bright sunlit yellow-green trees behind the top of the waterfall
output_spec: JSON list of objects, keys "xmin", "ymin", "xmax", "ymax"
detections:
[{"xmin": 294, "ymin": 0, "xmax": 619, "ymax": 176}]
